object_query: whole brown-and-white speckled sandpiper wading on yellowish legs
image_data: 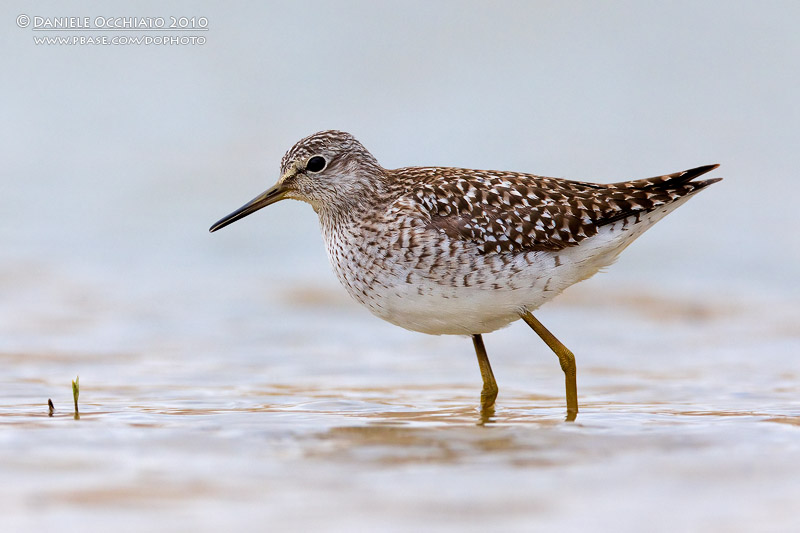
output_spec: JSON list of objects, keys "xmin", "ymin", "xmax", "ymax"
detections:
[{"xmin": 210, "ymin": 130, "xmax": 721, "ymax": 420}]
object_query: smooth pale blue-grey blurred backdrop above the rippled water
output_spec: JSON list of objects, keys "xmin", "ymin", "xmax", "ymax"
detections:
[{"xmin": 0, "ymin": 2, "xmax": 800, "ymax": 304}]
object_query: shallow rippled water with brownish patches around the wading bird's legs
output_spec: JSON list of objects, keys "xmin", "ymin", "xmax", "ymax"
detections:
[{"xmin": 0, "ymin": 284, "xmax": 800, "ymax": 531}]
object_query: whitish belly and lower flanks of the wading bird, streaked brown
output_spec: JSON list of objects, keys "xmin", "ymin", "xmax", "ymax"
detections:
[{"xmin": 328, "ymin": 206, "xmax": 682, "ymax": 335}]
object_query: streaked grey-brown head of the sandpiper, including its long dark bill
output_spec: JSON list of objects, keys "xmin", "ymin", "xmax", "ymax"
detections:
[{"xmin": 209, "ymin": 130, "xmax": 385, "ymax": 232}]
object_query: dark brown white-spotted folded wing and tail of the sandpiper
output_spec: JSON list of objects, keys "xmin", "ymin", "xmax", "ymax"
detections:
[{"xmin": 395, "ymin": 165, "xmax": 718, "ymax": 254}]
